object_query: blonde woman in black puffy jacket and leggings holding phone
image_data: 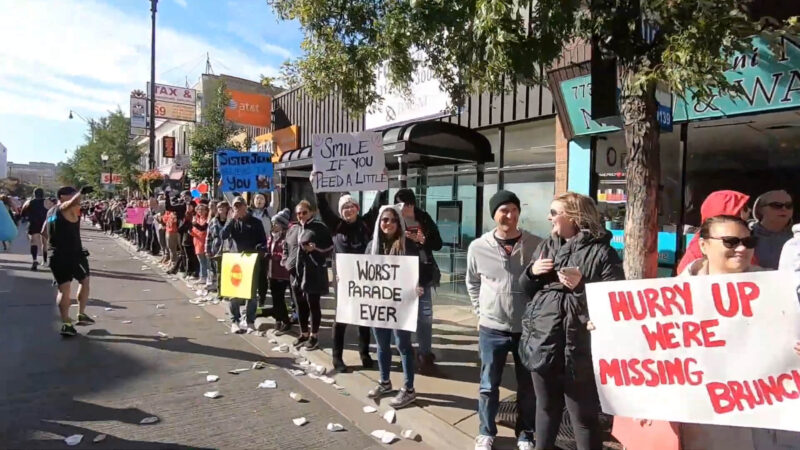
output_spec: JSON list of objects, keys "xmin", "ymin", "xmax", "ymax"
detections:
[{"xmin": 519, "ymin": 192, "xmax": 625, "ymax": 450}]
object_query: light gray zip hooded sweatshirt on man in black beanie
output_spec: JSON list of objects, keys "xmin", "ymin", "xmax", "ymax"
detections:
[{"xmin": 467, "ymin": 230, "xmax": 542, "ymax": 333}]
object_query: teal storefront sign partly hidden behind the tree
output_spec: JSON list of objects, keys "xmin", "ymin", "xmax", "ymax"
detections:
[{"xmin": 560, "ymin": 37, "xmax": 800, "ymax": 136}]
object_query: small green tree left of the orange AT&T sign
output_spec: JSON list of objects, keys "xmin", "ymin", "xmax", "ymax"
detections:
[{"xmin": 189, "ymin": 80, "xmax": 237, "ymax": 180}]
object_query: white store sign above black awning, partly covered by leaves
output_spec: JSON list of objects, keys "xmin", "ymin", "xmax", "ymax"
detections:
[{"xmin": 365, "ymin": 52, "xmax": 450, "ymax": 130}]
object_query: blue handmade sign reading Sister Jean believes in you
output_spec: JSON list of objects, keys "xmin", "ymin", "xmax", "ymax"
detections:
[{"xmin": 217, "ymin": 150, "xmax": 275, "ymax": 192}]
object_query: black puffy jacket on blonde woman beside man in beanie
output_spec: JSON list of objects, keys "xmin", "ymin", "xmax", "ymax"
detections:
[{"xmin": 519, "ymin": 232, "xmax": 625, "ymax": 380}]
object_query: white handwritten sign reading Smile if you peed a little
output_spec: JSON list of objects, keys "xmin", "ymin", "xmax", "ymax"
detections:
[{"xmin": 311, "ymin": 131, "xmax": 389, "ymax": 192}]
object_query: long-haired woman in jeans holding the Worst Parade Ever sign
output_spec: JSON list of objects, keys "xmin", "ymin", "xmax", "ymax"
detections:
[{"xmin": 366, "ymin": 206, "xmax": 422, "ymax": 408}]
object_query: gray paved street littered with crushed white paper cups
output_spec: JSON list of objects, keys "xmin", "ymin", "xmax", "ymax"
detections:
[{"xmin": 0, "ymin": 228, "xmax": 394, "ymax": 449}]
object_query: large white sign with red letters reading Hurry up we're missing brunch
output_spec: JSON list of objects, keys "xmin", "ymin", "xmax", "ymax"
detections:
[{"xmin": 586, "ymin": 272, "xmax": 800, "ymax": 431}]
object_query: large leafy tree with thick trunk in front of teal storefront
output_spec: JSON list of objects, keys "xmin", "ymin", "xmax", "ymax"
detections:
[{"xmin": 268, "ymin": 0, "xmax": 797, "ymax": 278}]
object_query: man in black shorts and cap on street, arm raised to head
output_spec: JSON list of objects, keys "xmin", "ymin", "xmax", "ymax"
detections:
[{"xmin": 44, "ymin": 186, "xmax": 94, "ymax": 337}]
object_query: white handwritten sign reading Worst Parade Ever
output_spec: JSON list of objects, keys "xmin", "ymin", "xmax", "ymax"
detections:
[{"xmin": 336, "ymin": 253, "xmax": 419, "ymax": 332}]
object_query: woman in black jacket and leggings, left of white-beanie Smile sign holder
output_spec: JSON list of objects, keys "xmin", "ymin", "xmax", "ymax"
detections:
[{"xmin": 287, "ymin": 200, "xmax": 333, "ymax": 350}]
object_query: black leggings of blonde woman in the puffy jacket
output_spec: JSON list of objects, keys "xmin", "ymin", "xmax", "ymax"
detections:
[{"xmin": 532, "ymin": 372, "xmax": 603, "ymax": 450}]
